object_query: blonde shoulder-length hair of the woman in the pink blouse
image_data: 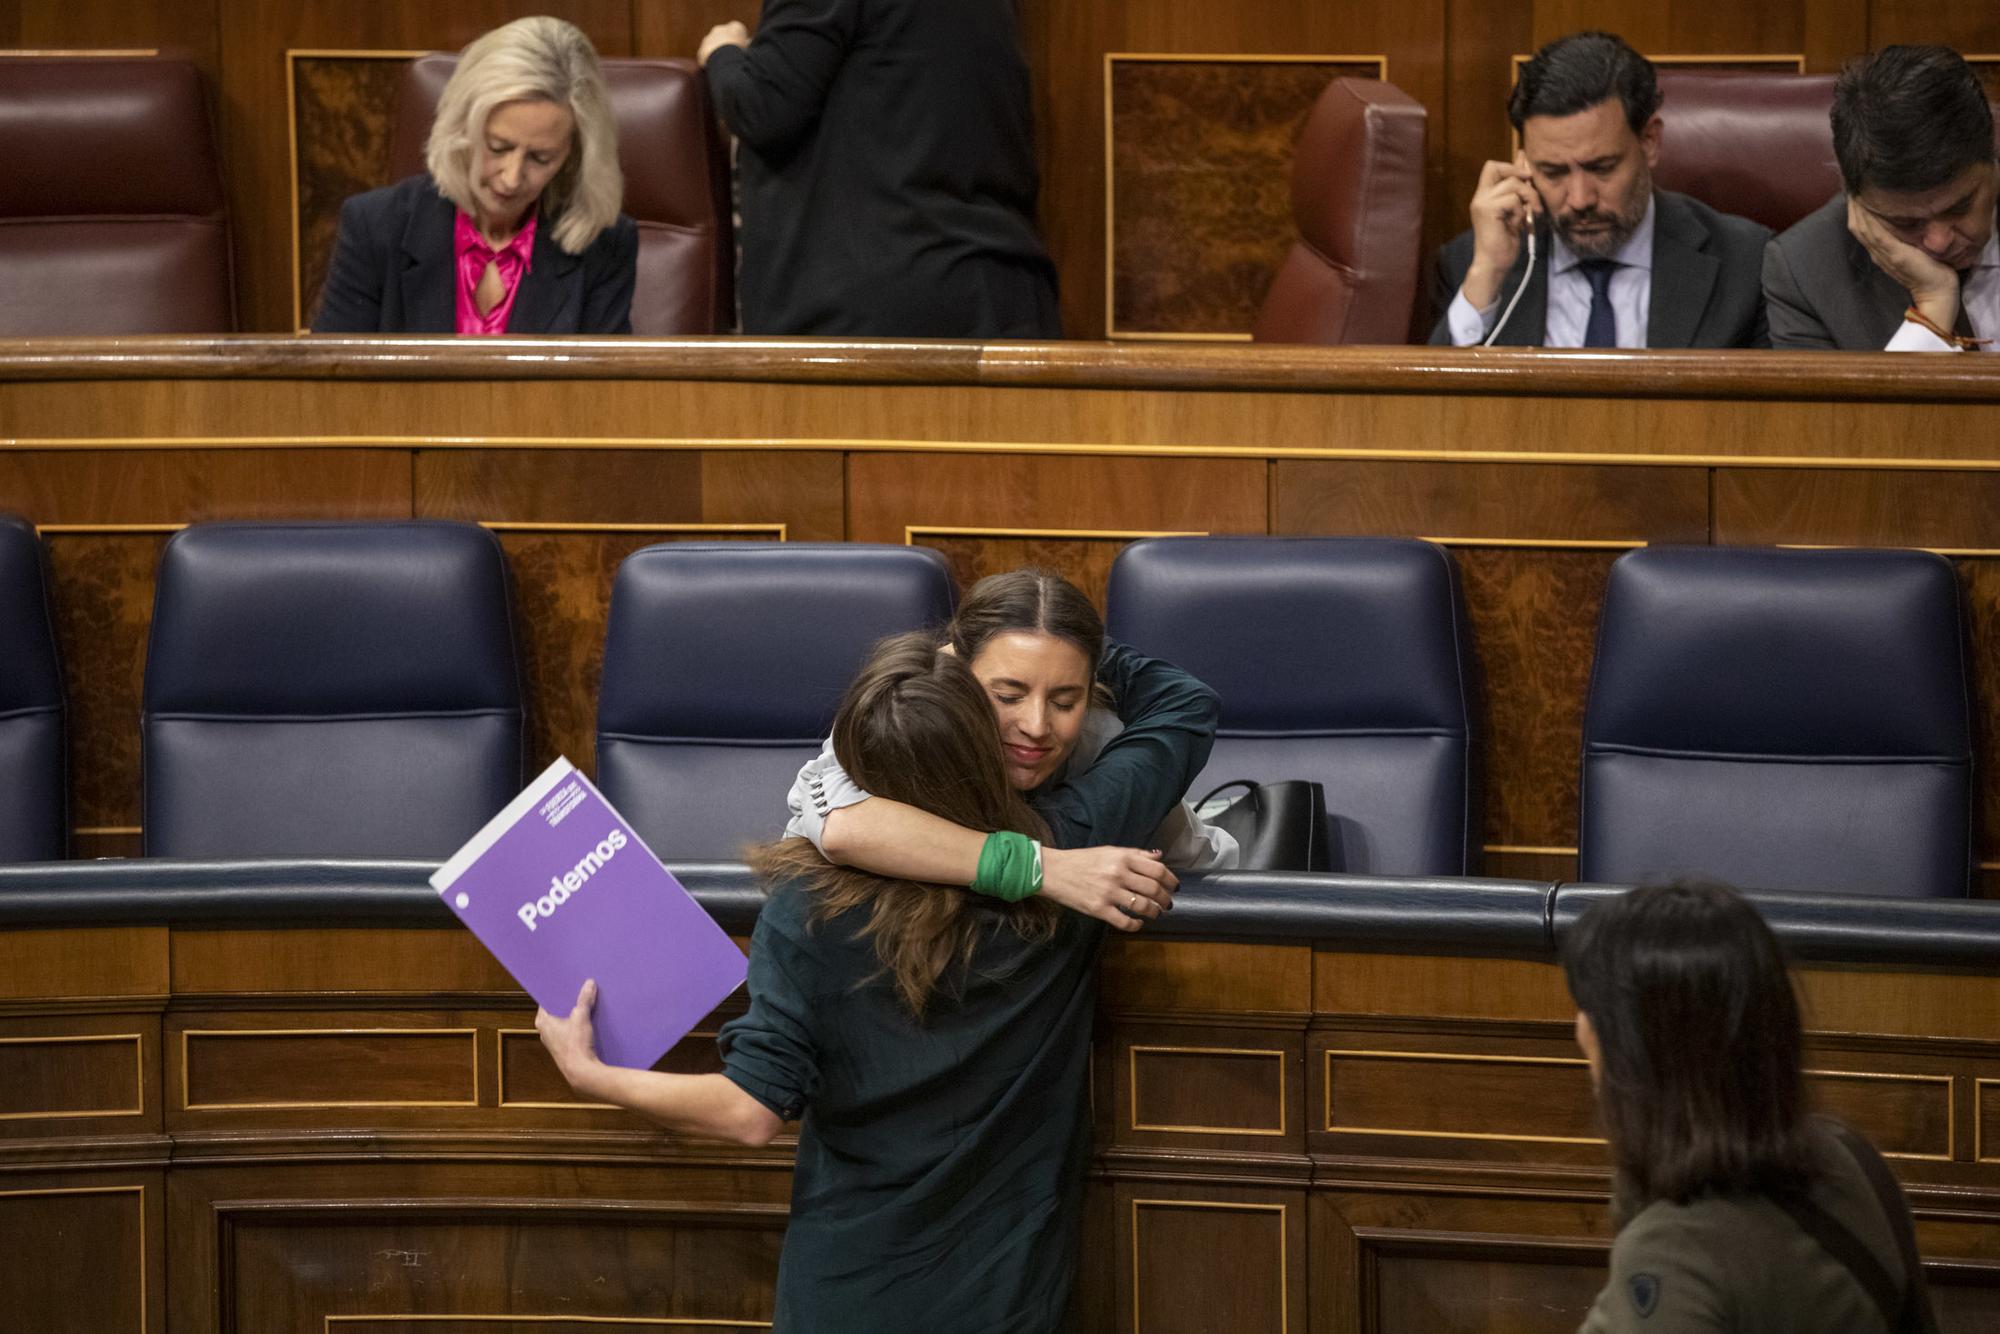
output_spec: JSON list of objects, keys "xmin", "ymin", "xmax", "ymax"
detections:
[{"xmin": 424, "ymin": 16, "xmax": 624, "ymax": 254}]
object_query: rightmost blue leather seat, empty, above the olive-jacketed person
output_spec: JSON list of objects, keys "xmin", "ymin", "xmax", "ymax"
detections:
[{"xmin": 1578, "ymin": 546, "xmax": 1974, "ymax": 896}]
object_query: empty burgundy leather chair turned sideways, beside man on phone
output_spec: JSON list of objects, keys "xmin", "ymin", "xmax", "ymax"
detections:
[{"xmin": 1250, "ymin": 78, "xmax": 1424, "ymax": 342}]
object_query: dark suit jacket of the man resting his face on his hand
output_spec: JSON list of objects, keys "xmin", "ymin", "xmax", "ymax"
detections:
[{"xmin": 1764, "ymin": 194, "xmax": 1972, "ymax": 352}]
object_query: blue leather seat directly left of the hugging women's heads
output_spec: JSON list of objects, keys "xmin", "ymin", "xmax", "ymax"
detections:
[{"xmin": 598, "ymin": 542, "xmax": 952, "ymax": 862}]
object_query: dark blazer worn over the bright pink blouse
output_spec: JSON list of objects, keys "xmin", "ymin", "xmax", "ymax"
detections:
[{"xmin": 312, "ymin": 174, "xmax": 638, "ymax": 334}]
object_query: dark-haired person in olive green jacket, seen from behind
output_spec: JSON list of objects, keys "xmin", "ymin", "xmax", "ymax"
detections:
[{"xmin": 1562, "ymin": 884, "xmax": 1936, "ymax": 1334}]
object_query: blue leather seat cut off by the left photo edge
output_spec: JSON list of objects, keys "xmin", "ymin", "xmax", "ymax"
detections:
[{"xmin": 0, "ymin": 514, "xmax": 70, "ymax": 862}]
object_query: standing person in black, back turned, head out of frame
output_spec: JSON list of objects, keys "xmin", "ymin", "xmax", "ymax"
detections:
[{"xmin": 700, "ymin": 0, "xmax": 1062, "ymax": 338}]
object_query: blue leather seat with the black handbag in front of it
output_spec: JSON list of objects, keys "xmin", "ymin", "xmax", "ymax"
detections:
[{"xmin": 1106, "ymin": 538, "xmax": 1478, "ymax": 876}]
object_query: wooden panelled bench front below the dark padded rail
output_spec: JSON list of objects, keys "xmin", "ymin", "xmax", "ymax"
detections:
[{"xmin": 0, "ymin": 908, "xmax": 2000, "ymax": 1334}]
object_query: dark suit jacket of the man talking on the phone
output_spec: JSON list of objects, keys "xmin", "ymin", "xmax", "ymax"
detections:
[{"xmin": 1430, "ymin": 190, "xmax": 1770, "ymax": 348}]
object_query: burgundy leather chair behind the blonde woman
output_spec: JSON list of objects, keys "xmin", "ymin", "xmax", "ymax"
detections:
[{"xmin": 388, "ymin": 56, "xmax": 736, "ymax": 338}]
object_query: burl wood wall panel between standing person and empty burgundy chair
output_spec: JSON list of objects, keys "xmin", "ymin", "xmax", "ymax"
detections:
[{"xmin": 1104, "ymin": 54, "xmax": 1382, "ymax": 338}]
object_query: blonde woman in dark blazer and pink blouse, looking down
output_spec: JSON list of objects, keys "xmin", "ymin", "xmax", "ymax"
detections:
[{"xmin": 312, "ymin": 18, "xmax": 638, "ymax": 334}]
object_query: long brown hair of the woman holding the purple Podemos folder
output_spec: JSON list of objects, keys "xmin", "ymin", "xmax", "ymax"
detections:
[{"xmin": 750, "ymin": 632, "xmax": 1060, "ymax": 1020}]
